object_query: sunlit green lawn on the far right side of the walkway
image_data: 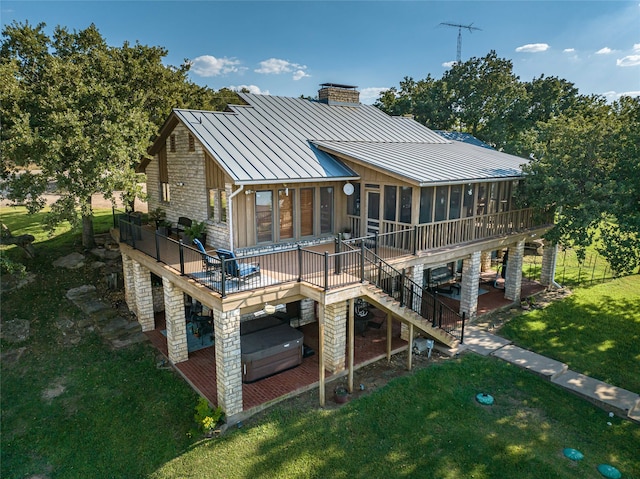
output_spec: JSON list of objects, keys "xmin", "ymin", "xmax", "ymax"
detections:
[{"xmin": 500, "ymin": 275, "xmax": 640, "ymax": 393}]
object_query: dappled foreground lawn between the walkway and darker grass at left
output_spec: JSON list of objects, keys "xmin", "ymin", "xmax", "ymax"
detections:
[{"xmin": 152, "ymin": 355, "xmax": 640, "ymax": 479}]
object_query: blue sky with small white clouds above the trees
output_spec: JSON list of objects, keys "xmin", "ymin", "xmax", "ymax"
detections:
[{"xmin": 0, "ymin": 0, "xmax": 640, "ymax": 104}]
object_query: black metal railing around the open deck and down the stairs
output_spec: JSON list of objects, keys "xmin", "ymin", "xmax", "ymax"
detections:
[{"xmin": 119, "ymin": 217, "xmax": 464, "ymax": 341}]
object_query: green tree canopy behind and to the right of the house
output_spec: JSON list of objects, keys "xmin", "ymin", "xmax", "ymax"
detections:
[{"xmin": 376, "ymin": 51, "xmax": 640, "ymax": 273}]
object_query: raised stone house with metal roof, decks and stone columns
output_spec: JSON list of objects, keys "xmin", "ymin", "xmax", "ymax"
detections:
[{"xmin": 120, "ymin": 83, "xmax": 556, "ymax": 417}]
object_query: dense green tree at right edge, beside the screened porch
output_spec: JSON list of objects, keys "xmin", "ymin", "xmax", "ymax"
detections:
[{"xmin": 522, "ymin": 96, "xmax": 640, "ymax": 274}]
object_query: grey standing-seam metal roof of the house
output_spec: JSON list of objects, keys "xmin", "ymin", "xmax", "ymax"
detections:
[{"xmin": 149, "ymin": 93, "xmax": 526, "ymax": 185}]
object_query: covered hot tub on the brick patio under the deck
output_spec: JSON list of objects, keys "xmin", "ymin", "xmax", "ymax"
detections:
[{"xmin": 240, "ymin": 321, "xmax": 304, "ymax": 383}]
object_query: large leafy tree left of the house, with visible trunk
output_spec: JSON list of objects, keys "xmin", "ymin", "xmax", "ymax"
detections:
[{"xmin": 0, "ymin": 22, "xmax": 226, "ymax": 247}]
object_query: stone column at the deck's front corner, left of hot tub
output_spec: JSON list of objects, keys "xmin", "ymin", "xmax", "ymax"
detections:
[{"xmin": 213, "ymin": 309, "xmax": 242, "ymax": 416}]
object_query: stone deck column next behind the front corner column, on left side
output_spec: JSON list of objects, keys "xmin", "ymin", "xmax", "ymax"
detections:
[{"xmin": 162, "ymin": 278, "xmax": 189, "ymax": 364}]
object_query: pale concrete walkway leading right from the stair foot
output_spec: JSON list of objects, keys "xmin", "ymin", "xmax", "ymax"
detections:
[{"xmin": 458, "ymin": 326, "xmax": 640, "ymax": 423}]
